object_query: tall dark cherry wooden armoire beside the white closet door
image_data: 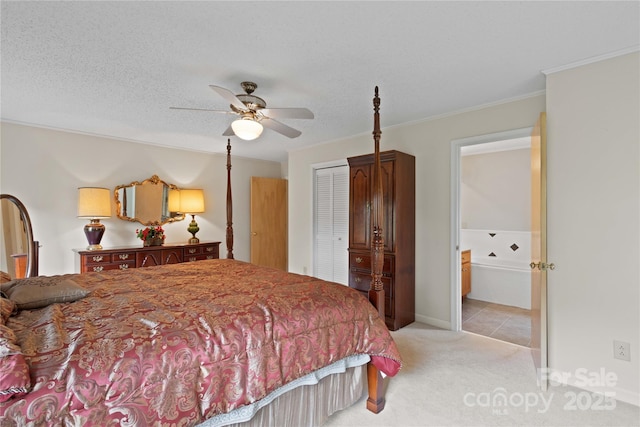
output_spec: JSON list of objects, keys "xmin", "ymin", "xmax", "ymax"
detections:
[{"xmin": 347, "ymin": 151, "xmax": 416, "ymax": 331}]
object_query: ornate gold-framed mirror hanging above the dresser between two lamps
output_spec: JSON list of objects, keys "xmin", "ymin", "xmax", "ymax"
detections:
[{"xmin": 114, "ymin": 175, "xmax": 184, "ymax": 225}]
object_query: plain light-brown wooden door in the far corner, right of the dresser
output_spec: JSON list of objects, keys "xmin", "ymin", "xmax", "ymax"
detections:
[{"xmin": 251, "ymin": 176, "xmax": 288, "ymax": 271}]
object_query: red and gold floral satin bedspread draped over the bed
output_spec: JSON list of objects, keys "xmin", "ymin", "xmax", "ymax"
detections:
[{"xmin": 0, "ymin": 259, "xmax": 401, "ymax": 426}]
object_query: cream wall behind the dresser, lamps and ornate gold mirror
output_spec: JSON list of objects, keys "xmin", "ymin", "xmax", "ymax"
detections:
[{"xmin": 0, "ymin": 123, "xmax": 281, "ymax": 275}]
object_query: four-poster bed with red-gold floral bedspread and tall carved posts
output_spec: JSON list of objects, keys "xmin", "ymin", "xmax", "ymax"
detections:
[{"xmin": 0, "ymin": 87, "xmax": 401, "ymax": 426}]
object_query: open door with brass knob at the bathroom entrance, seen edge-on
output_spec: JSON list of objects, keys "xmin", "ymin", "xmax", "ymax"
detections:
[{"xmin": 531, "ymin": 113, "xmax": 548, "ymax": 390}]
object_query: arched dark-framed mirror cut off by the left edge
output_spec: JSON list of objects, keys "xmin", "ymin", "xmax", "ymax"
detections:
[{"xmin": 0, "ymin": 194, "xmax": 39, "ymax": 279}]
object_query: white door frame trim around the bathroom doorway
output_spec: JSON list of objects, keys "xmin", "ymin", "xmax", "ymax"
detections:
[{"xmin": 449, "ymin": 126, "xmax": 533, "ymax": 331}]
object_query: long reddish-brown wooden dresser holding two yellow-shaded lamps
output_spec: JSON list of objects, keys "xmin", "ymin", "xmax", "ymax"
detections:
[{"xmin": 74, "ymin": 242, "xmax": 220, "ymax": 273}]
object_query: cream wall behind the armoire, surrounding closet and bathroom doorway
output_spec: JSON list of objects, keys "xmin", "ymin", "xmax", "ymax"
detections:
[{"xmin": 289, "ymin": 93, "xmax": 545, "ymax": 328}]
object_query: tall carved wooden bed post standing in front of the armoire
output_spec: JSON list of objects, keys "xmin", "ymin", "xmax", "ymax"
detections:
[{"xmin": 367, "ymin": 86, "xmax": 385, "ymax": 414}]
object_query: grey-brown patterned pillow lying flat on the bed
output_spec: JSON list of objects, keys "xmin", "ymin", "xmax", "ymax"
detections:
[{"xmin": 1, "ymin": 276, "xmax": 90, "ymax": 310}]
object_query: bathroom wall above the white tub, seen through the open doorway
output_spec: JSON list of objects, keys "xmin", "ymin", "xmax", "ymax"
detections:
[{"xmin": 460, "ymin": 148, "xmax": 531, "ymax": 231}]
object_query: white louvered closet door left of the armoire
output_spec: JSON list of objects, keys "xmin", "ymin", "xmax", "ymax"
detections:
[{"xmin": 314, "ymin": 166, "xmax": 349, "ymax": 285}]
